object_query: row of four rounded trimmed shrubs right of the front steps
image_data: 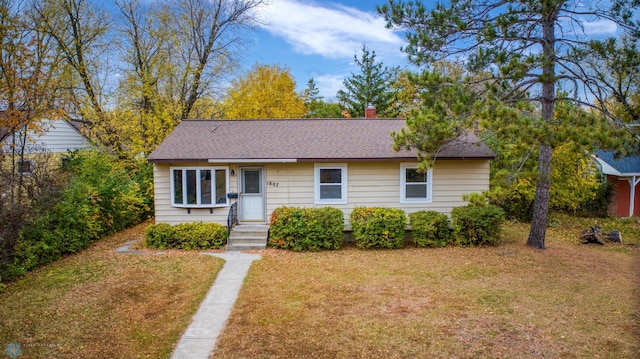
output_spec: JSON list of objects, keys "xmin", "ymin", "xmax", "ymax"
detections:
[{"xmin": 269, "ymin": 204, "xmax": 505, "ymax": 251}]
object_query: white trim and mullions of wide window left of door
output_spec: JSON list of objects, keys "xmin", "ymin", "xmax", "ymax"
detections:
[{"xmin": 169, "ymin": 166, "xmax": 229, "ymax": 208}]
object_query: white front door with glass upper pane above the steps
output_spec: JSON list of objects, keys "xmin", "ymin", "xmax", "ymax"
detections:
[{"xmin": 240, "ymin": 167, "xmax": 264, "ymax": 222}]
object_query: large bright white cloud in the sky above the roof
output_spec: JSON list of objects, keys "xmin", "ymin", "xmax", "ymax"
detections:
[{"xmin": 262, "ymin": 0, "xmax": 403, "ymax": 59}]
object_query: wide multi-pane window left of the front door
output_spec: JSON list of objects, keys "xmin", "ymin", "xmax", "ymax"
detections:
[{"xmin": 171, "ymin": 167, "xmax": 229, "ymax": 208}]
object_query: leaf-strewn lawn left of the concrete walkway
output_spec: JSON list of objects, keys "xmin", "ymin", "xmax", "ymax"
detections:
[{"xmin": 0, "ymin": 224, "xmax": 223, "ymax": 358}]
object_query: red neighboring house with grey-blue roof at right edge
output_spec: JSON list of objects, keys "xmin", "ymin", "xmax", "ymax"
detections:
[{"xmin": 595, "ymin": 151, "xmax": 640, "ymax": 217}]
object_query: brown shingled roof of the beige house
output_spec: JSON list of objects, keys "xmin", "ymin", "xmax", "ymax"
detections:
[{"xmin": 148, "ymin": 119, "xmax": 495, "ymax": 162}]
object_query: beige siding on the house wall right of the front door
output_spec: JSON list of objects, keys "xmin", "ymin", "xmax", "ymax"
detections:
[{"xmin": 267, "ymin": 161, "xmax": 489, "ymax": 224}]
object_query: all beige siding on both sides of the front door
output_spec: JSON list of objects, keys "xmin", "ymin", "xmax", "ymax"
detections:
[{"xmin": 154, "ymin": 160, "xmax": 489, "ymax": 228}]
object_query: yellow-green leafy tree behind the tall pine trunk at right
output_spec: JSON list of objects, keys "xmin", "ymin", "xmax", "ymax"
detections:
[{"xmin": 487, "ymin": 102, "xmax": 606, "ymax": 220}]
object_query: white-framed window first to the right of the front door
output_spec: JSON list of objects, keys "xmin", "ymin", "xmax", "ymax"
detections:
[{"xmin": 314, "ymin": 164, "xmax": 347, "ymax": 204}]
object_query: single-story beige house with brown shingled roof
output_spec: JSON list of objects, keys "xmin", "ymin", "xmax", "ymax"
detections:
[{"xmin": 148, "ymin": 118, "xmax": 495, "ymax": 229}]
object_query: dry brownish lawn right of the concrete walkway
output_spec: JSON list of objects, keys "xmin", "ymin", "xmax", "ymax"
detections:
[{"xmin": 215, "ymin": 223, "xmax": 640, "ymax": 358}]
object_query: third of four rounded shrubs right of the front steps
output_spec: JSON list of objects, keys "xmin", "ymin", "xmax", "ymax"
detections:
[{"xmin": 409, "ymin": 211, "xmax": 451, "ymax": 247}]
